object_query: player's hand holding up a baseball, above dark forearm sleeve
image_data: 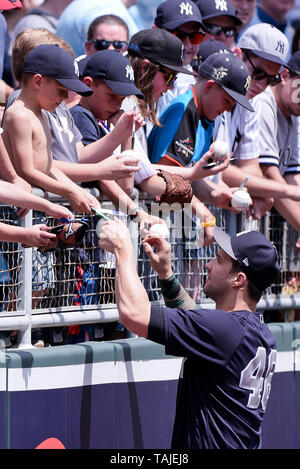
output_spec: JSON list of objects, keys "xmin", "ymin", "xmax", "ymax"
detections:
[{"xmin": 142, "ymin": 233, "xmax": 173, "ymax": 280}]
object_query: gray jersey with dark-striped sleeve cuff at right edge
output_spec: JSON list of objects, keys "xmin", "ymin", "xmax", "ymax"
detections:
[{"xmin": 259, "ymin": 88, "xmax": 300, "ymax": 176}]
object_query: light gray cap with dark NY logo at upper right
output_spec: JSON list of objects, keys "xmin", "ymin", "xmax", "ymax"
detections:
[{"xmin": 237, "ymin": 23, "xmax": 289, "ymax": 66}]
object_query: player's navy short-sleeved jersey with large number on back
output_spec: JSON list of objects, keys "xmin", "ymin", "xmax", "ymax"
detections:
[{"xmin": 148, "ymin": 306, "xmax": 276, "ymax": 449}]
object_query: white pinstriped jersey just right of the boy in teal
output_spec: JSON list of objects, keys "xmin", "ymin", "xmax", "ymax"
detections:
[{"xmin": 214, "ymin": 97, "xmax": 260, "ymax": 160}]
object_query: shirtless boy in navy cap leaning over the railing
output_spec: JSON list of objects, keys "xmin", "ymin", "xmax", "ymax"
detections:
[{"xmin": 3, "ymin": 44, "xmax": 98, "ymax": 213}]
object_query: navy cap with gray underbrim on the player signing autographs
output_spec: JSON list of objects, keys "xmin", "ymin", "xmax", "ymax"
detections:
[{"xmin": 214, "ymin": 226, "xmax": 280, "ymax": 292}]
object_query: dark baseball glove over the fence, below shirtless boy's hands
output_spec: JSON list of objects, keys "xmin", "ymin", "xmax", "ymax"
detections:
[{"xmin": 38, "ymin": 220, "xmax": 89, "ymax": 253}]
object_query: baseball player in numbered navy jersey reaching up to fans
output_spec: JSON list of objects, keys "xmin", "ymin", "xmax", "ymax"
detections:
[{"xmin": 99, "ymin": 220, "xmax": 279, "ymax": 449}]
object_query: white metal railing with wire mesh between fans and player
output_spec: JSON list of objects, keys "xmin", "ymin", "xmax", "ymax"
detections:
[{"xmin": 0, "ymin": 190, "xmax": 300, "ymax": 348}]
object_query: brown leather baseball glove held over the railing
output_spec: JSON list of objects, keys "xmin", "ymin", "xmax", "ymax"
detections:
[{"xmin": 157, "ymin": 169, "xmax": 193, "ymax": 207}]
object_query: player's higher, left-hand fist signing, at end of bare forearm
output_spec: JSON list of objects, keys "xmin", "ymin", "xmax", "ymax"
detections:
[{"xmin": 98, "ymin": 218, "xmax": 132, "ymax": 254}]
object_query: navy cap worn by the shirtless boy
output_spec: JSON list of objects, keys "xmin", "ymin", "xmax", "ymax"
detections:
[{"xmin": 22, "ymin": 44, "xmax": 93, "ymax": 96}]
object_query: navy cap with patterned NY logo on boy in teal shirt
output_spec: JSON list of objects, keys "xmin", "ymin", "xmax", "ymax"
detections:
[{"xmin": 198, "ymin": 52, "xmax": 254, "ymax": 111}]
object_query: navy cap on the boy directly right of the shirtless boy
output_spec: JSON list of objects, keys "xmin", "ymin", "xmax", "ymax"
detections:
[{"xmin": 82, "ymin": 49, "xmax": 144, "ymax": 99}]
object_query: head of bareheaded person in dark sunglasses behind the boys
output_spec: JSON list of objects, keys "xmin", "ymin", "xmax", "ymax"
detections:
[{"xmin": 84, "ymin": 15, "xmax": 129, "ymax": 56}]
